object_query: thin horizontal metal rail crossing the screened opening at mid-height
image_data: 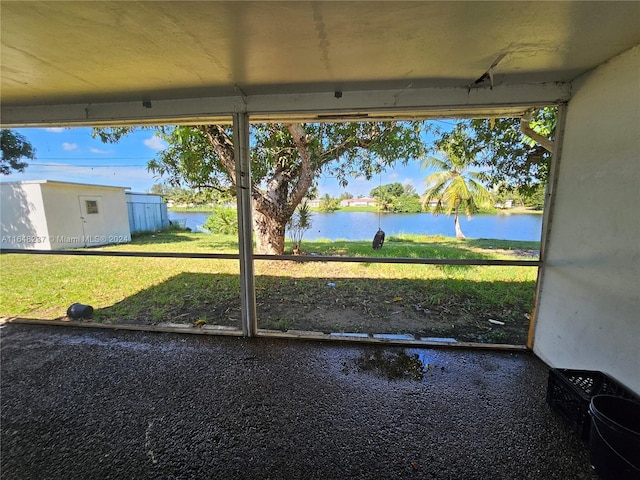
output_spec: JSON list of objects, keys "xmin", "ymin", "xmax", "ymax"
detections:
[{"xmin": 0, "ymin": 248, "xmax": 542, "ymax": 267}]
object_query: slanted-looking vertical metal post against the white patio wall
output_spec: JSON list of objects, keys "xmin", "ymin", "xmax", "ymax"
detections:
[{"xmin": 527, "ymin": 103, "xmax": 567, "ymax": 350}]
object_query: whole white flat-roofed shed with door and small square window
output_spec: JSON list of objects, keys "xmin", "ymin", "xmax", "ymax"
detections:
[{"xmin": 0, "ymin": 180, "xmax": 131, "ymax": 250}]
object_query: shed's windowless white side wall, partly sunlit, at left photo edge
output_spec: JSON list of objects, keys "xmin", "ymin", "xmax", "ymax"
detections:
[{"xmin": 0, "ymin": 182, "xmax": 51, "ymax": 250}]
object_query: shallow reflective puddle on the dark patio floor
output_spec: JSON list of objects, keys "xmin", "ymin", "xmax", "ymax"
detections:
[{"xmin": 343, "ymin": 349, "xmax": 444, "ymax": 382}]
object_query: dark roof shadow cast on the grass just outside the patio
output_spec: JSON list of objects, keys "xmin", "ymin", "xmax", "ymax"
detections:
[{"xmin": 94, "ymin": 273, "xmax": 535, "ymax": 345}]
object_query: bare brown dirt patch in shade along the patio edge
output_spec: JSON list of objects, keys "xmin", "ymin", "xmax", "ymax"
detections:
[{"xmin": 104, "ymin": 284, "xmax": 529, "ymax": 345}]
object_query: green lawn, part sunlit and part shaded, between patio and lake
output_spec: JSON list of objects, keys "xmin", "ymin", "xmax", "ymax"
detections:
[{"xmin": 0, "ymin": 232, "xmax": 539, "ymax": 344}]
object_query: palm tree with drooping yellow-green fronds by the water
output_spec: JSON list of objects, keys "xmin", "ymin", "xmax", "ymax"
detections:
[{"xmin": 422, "ymin": 130, "xmax": 492, "ymax": 239}]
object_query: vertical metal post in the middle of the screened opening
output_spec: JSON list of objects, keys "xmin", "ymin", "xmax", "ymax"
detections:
[{"xmin": 233, "ymin": 113, "xmax": 258, "ymax": 337}]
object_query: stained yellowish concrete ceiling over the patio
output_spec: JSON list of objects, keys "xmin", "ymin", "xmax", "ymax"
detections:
[{"xmin": 0, "ymin": 0, "xmax": 640, "ymax": 124}]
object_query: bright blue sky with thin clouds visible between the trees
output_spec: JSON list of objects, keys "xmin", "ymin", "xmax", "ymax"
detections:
[{"xmin": 0, "ymin": 126, "xmax": 448, "ymax": 197}]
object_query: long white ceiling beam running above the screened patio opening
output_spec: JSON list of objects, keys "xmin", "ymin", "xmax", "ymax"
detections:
[{"xmin": 0, "ymin": 83, "xmax": 571, "ymax": 128}]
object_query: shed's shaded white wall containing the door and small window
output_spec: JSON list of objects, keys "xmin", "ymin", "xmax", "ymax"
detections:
[{"xmin": 41, "ymin": 182, "xmax": 131, "ymax": 250}]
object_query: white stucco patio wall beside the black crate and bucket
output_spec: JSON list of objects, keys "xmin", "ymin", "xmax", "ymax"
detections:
[{"xmin": 533, "ymin": 46, "xmax": 640, "ymax": 394}]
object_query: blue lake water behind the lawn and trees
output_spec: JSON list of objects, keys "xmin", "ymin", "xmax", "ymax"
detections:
[{"xmin": 169, "ymin": 211, "xmax": 542, "ymax": 242}]
